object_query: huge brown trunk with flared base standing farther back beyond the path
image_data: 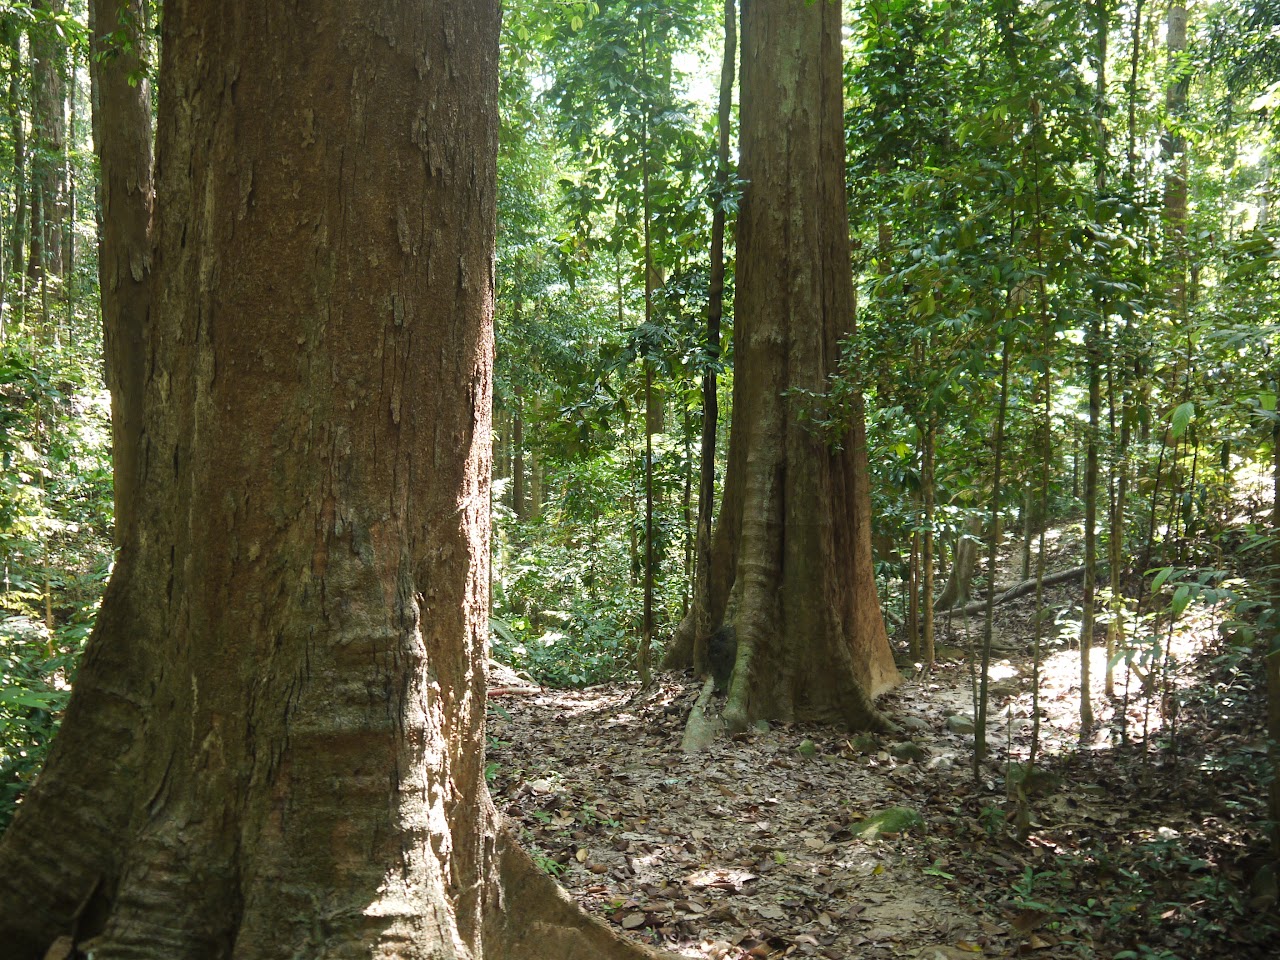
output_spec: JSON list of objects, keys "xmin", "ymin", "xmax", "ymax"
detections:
[{"xmin": 710, "ymin": 0, "xmax": 899, "ymax": 727}]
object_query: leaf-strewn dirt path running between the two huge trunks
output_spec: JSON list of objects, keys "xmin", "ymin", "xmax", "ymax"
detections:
[{"xmin": 490, "ymin": 684, "xmax": 989, "ymax": 957}]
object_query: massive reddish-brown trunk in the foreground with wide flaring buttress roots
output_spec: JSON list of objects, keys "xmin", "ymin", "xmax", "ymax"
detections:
[{"xmin": 0, "ymin": 7, "xmax": 675, "ymax": 960}]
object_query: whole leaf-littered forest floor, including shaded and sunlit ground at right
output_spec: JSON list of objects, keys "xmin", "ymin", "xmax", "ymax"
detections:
[{"xmin": 489, "ymin": 547, "xmax": 1280, "ymax": 960}]
